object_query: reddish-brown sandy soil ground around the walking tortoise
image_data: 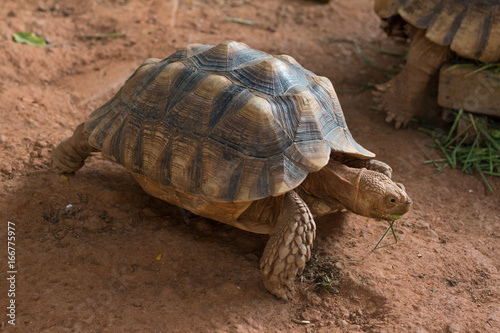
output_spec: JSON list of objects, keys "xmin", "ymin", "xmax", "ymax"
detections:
[{"xmin": 0, "ymin": 0, "xmax": 500, "ymax": 333}]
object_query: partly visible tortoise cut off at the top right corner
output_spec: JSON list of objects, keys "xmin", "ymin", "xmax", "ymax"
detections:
[{"xmin": 375, "ymin": 0, "xmax": 500, "ymax": 128}]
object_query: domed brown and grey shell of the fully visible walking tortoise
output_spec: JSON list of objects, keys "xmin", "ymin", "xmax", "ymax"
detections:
[{"xmin": 85, "ymin": 41, "xmax": 374, "ymax": 203}]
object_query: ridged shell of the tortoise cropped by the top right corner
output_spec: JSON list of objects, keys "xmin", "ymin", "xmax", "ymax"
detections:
[{"xmin": 375, "ymin": 0, "xmax": 500, "ymax": 62}]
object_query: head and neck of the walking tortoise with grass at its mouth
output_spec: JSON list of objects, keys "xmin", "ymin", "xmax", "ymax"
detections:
[{"xmin": 302, "ymin": 161, "xmax": 412, "ymax": 221}]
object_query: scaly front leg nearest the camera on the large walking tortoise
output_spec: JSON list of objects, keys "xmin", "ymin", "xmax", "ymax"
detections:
[{"xmin": 260, "ymin": 191, "xmax": 316, "ymax": 300}]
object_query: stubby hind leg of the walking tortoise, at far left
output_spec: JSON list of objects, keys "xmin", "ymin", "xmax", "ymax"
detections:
[{"xmin": 52, "ymin": 123, "xmax": 99, "ymax": 173}]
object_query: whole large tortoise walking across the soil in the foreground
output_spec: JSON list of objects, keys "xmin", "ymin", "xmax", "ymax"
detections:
[{"xmin": 52, "ymin": 41, "xmax": 412, "ymax": 299}]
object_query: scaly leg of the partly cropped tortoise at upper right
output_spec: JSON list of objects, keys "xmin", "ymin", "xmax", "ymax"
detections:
[{"xmin": 374, "ymin": 27, "xmax": 450, "ymax": 129}]
